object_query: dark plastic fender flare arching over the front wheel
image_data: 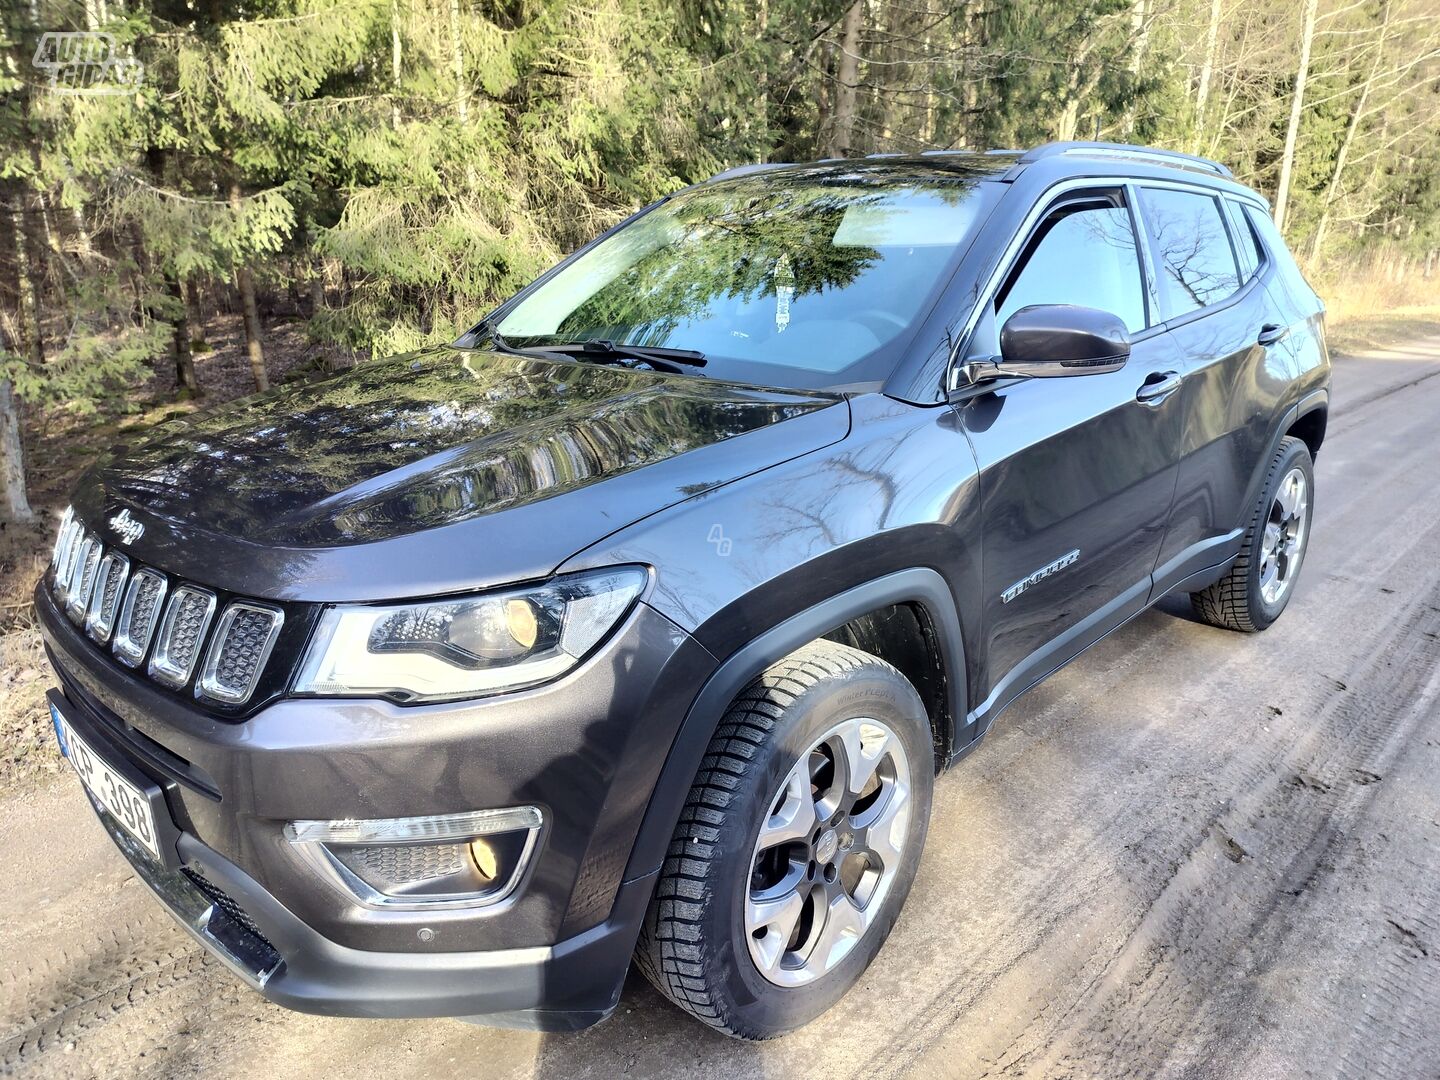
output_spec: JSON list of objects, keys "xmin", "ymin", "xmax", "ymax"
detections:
[{"xmin": 625, "ymin": 567, "xmax": 968, "ymax": 881}]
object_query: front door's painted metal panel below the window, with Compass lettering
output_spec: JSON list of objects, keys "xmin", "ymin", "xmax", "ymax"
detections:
[{"xmin": 960, "ymin": 334, "xmax": 1184, "ymax": 714}]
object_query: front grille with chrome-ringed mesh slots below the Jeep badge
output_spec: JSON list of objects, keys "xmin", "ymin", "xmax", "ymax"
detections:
[{"xmin": 50, "ymin": 510, "xmax": 285, "ymax": 706}]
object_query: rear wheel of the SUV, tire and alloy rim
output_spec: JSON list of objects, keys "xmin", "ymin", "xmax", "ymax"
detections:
[{"xmin": 1191, "ymin": 436, "xmax": 1315, "ymax": 634}]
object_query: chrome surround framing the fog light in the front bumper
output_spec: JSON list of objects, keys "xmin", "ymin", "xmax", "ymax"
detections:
[{"xmin": 285, "ymin": 806, "xmax": 544, "ymax": 912}]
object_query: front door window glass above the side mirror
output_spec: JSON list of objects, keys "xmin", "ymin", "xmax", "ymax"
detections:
[{"xmin": 995, "ymin": 203, "xmax": 1145, "ymax": 333}]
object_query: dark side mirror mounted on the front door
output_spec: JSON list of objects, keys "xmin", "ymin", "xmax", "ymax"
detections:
[{"xmin": 996, "ymin": 304, "xmax": 1130, "ymax": 379}]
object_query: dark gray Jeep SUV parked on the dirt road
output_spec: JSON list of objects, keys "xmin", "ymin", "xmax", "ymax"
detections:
[{"xmin": 35, "ymin": 144, "xmax": 1329, "ymax": 1038}]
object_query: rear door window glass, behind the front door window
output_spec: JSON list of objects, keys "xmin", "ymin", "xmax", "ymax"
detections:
[{"xmin": 1140, "ymin": 187, "xmax": 1240, "ymax": 318}]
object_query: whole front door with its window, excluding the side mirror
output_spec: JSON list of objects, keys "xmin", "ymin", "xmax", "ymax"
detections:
[{"xmin": 958, "ymin": 187, "xmax": 1184, "ymax": 714}]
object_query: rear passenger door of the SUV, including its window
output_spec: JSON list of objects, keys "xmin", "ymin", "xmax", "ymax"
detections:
[{"xmin": 1139, "ymin": 183, "xmax": 1295, "ymax": 595}]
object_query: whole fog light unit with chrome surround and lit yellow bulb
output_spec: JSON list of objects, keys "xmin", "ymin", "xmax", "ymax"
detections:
[{"xmin": 285, "ymin": 806, "xmax": 543, "ymax": 909}]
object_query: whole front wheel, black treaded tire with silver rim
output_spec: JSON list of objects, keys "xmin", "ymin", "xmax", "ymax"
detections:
[{"xmin": 636, "ymin": 641, "xmax": 935, "ymax": 1040}]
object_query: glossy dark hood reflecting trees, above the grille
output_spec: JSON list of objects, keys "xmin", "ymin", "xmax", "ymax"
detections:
[{"xmin": 76, "ymin": 348, "xmax": 848, "ymax": 599}]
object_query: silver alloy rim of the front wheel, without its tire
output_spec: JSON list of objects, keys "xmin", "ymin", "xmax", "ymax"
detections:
[{"xmin": 744, "ymin": 717, "xmax": 910, "ymax": 986}]
